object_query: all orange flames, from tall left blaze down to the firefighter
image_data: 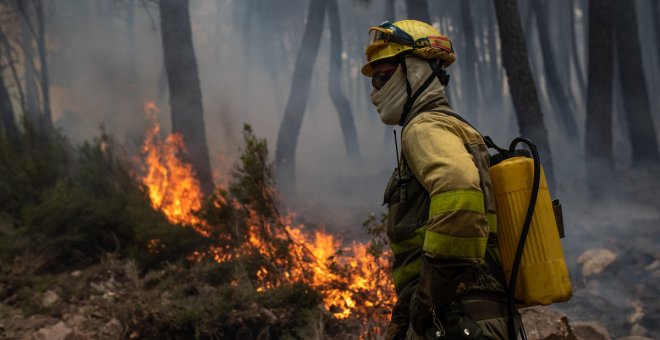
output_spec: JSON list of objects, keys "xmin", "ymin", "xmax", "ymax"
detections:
[{"xmin": 137, "ymin": 102, "xmax": 395, "ymax": 337}]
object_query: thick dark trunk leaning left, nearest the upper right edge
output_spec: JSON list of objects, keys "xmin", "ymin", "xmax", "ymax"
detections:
[{"xmin": 614, "ymin": 0, "xmax": 660, "ymax": 165}]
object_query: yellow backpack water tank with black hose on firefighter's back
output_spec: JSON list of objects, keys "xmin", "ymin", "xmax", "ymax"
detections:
[{"xmin": 485, "ymin": 137, "xmax": 571, "ymax": 336}]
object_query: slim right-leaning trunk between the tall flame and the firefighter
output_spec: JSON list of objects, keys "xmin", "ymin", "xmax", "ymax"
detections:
[{"xmin": 275, "ymin": 0, "xmax": 325, "ymax": 191}]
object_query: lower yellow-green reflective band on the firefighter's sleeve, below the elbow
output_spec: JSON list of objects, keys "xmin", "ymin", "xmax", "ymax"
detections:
[{"xmin": 423, "ymin": 230, "xmax": 488, "ymax": 259}]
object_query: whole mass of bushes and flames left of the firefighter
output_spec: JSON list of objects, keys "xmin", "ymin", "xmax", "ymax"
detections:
[{"xmin": 0, "ymin": 105, "xmax": 394, "ymax": 338}]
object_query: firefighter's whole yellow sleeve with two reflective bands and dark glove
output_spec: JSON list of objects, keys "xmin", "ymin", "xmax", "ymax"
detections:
[{"xmin": 403, "ymin": 117, "xmax": 489, "ymax": 334}]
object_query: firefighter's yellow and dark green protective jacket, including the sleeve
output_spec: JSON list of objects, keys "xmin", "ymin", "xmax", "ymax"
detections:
[{"xmin": 384, "ymin": 59, "xmax": 506, "ymax": 339}]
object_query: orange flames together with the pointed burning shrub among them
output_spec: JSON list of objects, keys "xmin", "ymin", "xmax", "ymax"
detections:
[{"xmin": 133, "ymin": 104, "xmax": 394, "ymax": 337}]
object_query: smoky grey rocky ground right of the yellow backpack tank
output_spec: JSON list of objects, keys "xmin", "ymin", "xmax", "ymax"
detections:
[{"xmin": 554, "ymin": 164, "xmax": 660, "ymax": 339}]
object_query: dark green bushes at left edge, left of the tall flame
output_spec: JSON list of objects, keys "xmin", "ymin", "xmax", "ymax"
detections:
[{"xmin": 0, "ymin": 122, "xmax": 202, "ymax": 274}]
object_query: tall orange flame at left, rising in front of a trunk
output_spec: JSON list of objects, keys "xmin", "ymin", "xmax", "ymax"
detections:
[{"xmin": 142, "ymin": 101, "xmax": 209, "ymax": 236}]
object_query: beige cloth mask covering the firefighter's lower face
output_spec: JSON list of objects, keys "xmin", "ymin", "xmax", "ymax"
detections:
[{"xmin": 371, "ymin": 66, "xmax": 408, "ymax": 125}]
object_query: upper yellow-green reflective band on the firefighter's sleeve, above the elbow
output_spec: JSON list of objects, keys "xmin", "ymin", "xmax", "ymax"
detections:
[{"xmin": 429, "ymin": 190, "xmax": 485, "ymax": 218}]
